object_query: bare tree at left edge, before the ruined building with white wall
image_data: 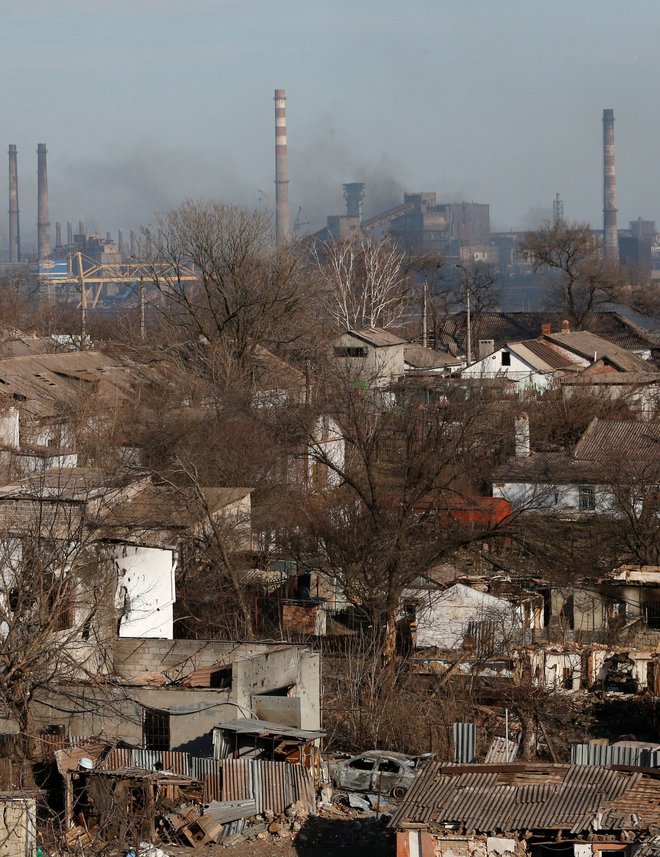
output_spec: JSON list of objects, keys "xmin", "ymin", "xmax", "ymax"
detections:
[{"xmin": 0, "ymin": 470, "xmax": 117, "ymax": 758}]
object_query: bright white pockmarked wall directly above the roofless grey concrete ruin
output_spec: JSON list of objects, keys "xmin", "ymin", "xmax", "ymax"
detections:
[{"xmin": 113, "ymin": 545, "xmax": 177, "ymax": 640}]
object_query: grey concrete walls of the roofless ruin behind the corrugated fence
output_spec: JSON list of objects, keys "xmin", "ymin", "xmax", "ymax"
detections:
[{"xmin": 33, "ymin": 639, "xmax": 321, "ymax": 755}]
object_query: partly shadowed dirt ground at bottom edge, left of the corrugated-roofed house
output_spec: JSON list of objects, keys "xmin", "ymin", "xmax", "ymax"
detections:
[{"xmin": 163, "ymin": 816, "xmax": 394, "ymax": 857}]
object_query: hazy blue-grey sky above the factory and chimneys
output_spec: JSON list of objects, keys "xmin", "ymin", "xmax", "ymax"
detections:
[{"xmin": 0, "ymin": 0, "xmax": 660, "ymax": 244}]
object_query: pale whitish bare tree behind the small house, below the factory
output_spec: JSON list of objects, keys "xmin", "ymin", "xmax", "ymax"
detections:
[{"xmin": 312, "ymin": 233, "xmax": 408, "ymax": 330}]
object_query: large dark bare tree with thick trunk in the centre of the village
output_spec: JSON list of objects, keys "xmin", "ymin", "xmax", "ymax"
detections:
[{"xmin": 282, "ymin": 366, "xmax": 512, "ymax": 665}]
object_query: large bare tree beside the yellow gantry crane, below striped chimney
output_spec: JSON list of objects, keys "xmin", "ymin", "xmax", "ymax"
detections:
[{"xmin": 142, "ymin": 201, "xmax": 309, "ymax": 359}]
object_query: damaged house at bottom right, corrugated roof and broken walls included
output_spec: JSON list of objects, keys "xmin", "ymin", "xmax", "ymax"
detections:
[{"xmin": 389, "ymin": 762, "xmax": 660, "ymax": 857}]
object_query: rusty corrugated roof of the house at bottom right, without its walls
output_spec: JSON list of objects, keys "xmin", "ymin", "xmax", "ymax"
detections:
[{"xmin": 390, "ymin": 763, "xmax": 660, "ymax": 834}]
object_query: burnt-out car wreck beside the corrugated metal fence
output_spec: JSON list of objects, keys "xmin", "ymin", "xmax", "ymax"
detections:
[{"xmin": 328, "ymin": 750, "xmax": 435, "ymax": 798}]
